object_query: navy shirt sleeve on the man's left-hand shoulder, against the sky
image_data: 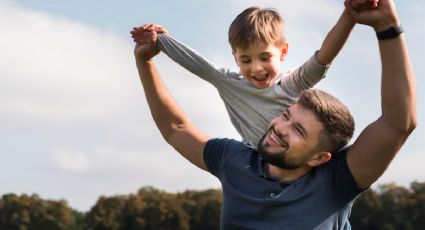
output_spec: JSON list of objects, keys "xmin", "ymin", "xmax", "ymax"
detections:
[{"xmin": 204, "ymin": 138, "xmax": 231, "ymax": 177}]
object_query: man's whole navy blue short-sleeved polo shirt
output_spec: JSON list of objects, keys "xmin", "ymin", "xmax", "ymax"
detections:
[{"xmin": 204, "ymin": 139, "xmax": 362, "ymax": 230}]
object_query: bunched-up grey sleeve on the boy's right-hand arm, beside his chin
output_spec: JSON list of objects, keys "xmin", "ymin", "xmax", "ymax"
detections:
[{"xmin": 280, "ymin": 52, "xmax": 330, "ymax": 97}]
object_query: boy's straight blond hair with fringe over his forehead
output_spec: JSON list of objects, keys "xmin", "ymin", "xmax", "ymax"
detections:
[{"xmin": 229, "ymin": 7, "xmax": 286, "ymax": 49}]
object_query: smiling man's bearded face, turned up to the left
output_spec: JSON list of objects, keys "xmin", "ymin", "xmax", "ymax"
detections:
[{"xmin": 258, "ymin": 104, "xmax": 323, "ymax": 169}]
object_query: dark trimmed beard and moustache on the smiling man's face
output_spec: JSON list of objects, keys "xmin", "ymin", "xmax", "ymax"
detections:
[{"xmin": 257, "ymin": 129, "xmax": 301, "ymax": 169}]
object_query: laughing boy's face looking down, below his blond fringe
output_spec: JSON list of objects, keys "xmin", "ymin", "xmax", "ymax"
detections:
[{"xmin": 233, "ymin": 42, "xmax": 288, "ymax": 89}]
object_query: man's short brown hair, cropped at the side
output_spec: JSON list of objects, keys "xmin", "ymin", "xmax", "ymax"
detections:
[{"xmin": 297, "ymin": 89, "xmax": 354, "ymax": 153}]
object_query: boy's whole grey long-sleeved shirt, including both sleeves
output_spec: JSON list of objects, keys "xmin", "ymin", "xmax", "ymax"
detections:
[{"xmin": 158, "ymin": 34, "xmax": 329, "ymax": 148}]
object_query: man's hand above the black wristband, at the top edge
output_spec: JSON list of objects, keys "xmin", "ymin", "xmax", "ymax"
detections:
[{"xmin": 344, "ymin": 0, "xmax": 400, "ymax": 31}]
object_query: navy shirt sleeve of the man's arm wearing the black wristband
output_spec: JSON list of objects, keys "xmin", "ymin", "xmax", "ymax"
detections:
[{"xmin": 330, "ymin": 147, "xmax": 364, "ymax": 200}]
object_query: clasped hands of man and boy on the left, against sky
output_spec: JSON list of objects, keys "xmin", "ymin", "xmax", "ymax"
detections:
[{"xmin": 130, "ymin": 24, "xmax": 168, "ymax": 62}]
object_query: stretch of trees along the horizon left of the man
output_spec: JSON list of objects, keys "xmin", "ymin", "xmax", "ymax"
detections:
[{"xmin": 0, "ymin": 187, "xmax": 222, "ymax": 230}]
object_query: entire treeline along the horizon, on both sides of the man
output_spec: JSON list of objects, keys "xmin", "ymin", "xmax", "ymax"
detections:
[{"xmin": 0, "ymin": 182, "xmax": 425, "ymax": 230}]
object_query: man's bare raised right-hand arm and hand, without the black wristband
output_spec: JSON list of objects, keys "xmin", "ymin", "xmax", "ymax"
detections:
[{"xmin": 346, "ymin": 0, "xmax": 416, "ymax": 188}]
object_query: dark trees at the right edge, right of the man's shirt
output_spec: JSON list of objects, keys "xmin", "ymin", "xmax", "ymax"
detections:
[{"xmin": 350, "ymin": 182, "xmax": 425, "ymax": 230}]
